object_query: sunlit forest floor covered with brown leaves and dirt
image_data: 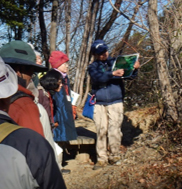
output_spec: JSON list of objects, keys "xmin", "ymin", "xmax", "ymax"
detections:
[{"xmin": 63, "ymin": 107, "xmax": 182, "ymax": 189}]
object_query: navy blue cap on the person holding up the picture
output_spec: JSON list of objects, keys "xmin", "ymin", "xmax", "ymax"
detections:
[{"xmin": 91, "ymin": 39, "xmax": 108, "ymax": 55}]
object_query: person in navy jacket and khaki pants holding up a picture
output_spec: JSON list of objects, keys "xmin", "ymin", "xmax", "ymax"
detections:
[{"xmin": 88, "ymin": 40, "xmax": 139, "ymax": 170}]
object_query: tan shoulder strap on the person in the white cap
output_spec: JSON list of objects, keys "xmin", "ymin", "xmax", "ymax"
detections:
[{"xmin": 0, "ymin": 122, "xmax": 23, "ymax": 142}]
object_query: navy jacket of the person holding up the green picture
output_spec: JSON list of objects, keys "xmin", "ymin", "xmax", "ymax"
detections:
[{"xmin": 88, "ymin": 58, "xmax": 137, "ymax": 105}]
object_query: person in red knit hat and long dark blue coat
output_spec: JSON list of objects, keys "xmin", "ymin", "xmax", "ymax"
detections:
[{"xmin": 42, "ymin": 51, "xmax": 77, "ymax": 142}]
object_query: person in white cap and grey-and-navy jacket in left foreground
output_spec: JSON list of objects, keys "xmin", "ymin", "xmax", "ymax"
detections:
[{"xmin": 0, "ymin": 57, "xmax": 66, "ymax": 189}]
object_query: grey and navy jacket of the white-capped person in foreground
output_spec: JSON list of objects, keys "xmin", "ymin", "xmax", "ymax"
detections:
[{"xmin": 0, "ymin": 114, "xmax": 66, "ymax": 189}]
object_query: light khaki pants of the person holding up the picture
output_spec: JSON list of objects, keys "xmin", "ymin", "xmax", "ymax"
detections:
[{"xmin": 94, "ymin": 102, "xmax": 123, "ymax": 162}]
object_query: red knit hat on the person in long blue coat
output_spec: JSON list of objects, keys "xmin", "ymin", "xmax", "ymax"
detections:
[{"xmin": 49, "ymin": 51, "xmax": 69, "ymax": 68}]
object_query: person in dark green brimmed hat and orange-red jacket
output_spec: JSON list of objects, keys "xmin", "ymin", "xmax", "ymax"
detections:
[{"xmin": 0, "ymin": 40, "xmax": 47, "ymax": 136}]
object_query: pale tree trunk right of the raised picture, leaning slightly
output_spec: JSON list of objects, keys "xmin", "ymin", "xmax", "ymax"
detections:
[{"xmin": 148, "ymin": 0, "xmax": 178, "ymax": 122}]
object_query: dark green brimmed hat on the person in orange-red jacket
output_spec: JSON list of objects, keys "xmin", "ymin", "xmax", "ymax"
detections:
[{"xmin": 0, "ymin": 40, "xmax": 47, "ymax": 72}]
